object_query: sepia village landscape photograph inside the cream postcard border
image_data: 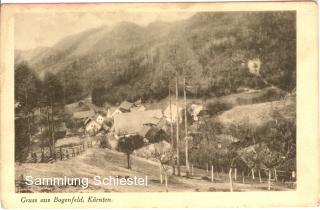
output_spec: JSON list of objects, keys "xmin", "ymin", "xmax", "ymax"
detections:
[{"xmin": 12, "ymin": 9, "xmax": 299, "ymax": 193}]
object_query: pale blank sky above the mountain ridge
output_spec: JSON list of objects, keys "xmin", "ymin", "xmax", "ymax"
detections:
[{"xmin": 14, "ymin": 11, "xmax": 193, "ymax": 50}]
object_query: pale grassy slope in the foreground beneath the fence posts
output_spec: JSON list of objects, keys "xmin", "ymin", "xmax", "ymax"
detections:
[{"xmin": 15, "ymin": 148, "xmax": 296, "ymax": 192}]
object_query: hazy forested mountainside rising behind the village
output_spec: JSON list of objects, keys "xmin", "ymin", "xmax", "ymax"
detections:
[{"xmin": 15, "ymin": 12, "xmax": 296, "ymax": 104}]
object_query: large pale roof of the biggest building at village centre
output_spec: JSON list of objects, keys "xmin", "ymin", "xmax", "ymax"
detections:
[{"xmin": 114, "ymin": 109, "xmax": 162, "ymax": 135}]
